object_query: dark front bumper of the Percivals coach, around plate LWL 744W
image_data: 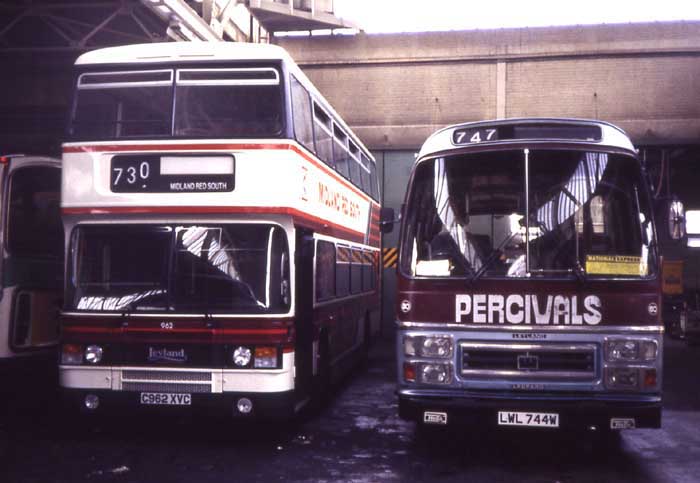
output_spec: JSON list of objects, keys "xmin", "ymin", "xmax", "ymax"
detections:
[{"xmin": 399, "ymin": 392, "xmax": 662, "ymax": 431}]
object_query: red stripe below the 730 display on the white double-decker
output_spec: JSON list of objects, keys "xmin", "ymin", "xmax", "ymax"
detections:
[{"xmin": 61, "ymin": 206, "xmax": 365, "ymax": 241}]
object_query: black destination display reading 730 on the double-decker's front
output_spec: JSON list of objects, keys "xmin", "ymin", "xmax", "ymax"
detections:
[{"xmin": 110, "ymin": 154, "xmax": 235, "ymax": 193}]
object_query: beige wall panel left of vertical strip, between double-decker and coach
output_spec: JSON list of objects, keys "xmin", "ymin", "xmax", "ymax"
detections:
[{"xmin": 304, "ymin": 62, "xmax": 496, "ymax": 149}]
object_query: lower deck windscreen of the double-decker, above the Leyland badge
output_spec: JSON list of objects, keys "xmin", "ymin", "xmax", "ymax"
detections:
[{"xmin": 66, "ymin": 224, "xmax": 290, "ymax": 314}]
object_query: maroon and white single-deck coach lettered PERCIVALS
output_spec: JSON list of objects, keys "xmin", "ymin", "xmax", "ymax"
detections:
[{"xmin": 397, "ymin": 119, "xmax": 679, "ymax": 432}]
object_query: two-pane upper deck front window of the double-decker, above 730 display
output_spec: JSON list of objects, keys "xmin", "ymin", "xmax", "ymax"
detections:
[{"xmin": 69, "ymin": 67, "xmax": 284, "ymax": 141}]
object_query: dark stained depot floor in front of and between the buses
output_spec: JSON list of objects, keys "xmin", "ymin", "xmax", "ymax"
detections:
[{"xmin": 0, "ymin": 340, "xmax": 700, "ymax": 483}]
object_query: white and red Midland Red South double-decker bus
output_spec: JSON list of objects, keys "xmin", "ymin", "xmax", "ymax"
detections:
[{"xmin": 59, "ymin": 42, "xmax": 380, "ymax": 418}]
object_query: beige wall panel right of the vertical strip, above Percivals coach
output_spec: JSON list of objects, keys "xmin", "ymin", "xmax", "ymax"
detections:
[{"xmin": 505, "ymin": 54, "xmax": 700, "ymax": 145}]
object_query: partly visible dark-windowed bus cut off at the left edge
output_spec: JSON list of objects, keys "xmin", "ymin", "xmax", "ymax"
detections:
[{"xmin": 0, "ymin": 155, "xmax": 63, "ymax": 396}]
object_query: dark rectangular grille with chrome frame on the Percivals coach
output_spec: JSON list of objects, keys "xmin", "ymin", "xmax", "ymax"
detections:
[{"xmin": 460, "ymin": 342, "xmax": 597, "ymax": 380}]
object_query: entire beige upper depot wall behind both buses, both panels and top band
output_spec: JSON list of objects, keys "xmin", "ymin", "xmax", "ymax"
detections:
[{"xmin": 276, "ymin": 22, "xmax": 700, "ymax": 149}]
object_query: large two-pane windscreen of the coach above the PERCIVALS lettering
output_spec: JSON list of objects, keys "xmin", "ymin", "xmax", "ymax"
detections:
[{"xmin": 401, "ymin": 149, "xmax": 656, "ymax": 280}]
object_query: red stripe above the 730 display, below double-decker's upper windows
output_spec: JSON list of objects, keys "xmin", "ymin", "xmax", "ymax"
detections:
[{"xmin": 63, "ymin": 143, "xmax": 379, "ymax": 206}]
